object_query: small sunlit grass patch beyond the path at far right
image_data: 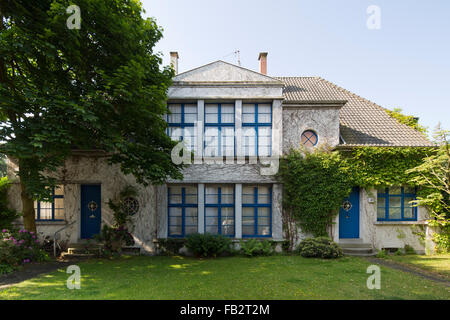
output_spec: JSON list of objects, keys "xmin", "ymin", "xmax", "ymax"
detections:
[{"xmin": 388, "ymin": 254, "xmax": 450, "ymax": 279}]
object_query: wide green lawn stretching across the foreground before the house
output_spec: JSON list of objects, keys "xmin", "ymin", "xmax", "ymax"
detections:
[{"xmin": 0, "ymin": 256, "xmax": 450, "ymax": 299}]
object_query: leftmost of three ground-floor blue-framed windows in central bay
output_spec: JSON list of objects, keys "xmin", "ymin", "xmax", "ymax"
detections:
[{"xmin": 168, "ymin": 185, "xmax": 198, "ymax": 237}]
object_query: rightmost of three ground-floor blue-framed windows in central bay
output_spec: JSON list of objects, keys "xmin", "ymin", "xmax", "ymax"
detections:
[{"xmin": 242, "ymin": 185, "xmax": 272, "ymax": 237}]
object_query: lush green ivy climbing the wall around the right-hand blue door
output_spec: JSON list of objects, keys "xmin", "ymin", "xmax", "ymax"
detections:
[{"xmin": 279, "ymin": 147, "xmax": 435, "ymax": 240}]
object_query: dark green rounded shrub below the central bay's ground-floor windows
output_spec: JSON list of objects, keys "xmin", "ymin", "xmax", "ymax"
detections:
[{"xmin": 185, "ymin": 233, "xmax": 232, "ymax": 257}]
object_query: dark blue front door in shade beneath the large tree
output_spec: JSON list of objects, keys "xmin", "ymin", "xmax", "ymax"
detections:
[{"xmin": 81, "ymin": 184, "xmax": 102, "ymax": 239}]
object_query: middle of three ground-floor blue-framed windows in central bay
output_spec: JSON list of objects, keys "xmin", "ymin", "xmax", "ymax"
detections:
[{"xmin": 205, "ymin": 185, "xmax": 234, "ymax": 236}]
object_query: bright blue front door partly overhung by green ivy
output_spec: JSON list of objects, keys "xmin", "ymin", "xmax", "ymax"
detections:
[{"xmin": 339, "ymin": 187, "xmax": 359, "ymax": 239}]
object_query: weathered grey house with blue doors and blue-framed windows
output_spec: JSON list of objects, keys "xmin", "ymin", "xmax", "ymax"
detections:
[{"xmin": 9, "ymin": 52, "xmax": 431, "ymax": 253}]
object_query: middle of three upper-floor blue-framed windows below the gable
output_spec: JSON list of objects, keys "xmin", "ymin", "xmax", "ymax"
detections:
[{"xmin": 204, "ymin": 103, "xmax": 234, "ymax": 157}]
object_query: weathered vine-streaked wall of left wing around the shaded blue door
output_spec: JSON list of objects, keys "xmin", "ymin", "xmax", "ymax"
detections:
[{"xmin": 8, "ymin": 156, "xmax": 156, "ymax": 253}]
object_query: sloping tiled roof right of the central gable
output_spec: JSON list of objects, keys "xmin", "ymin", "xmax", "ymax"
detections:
[{"xmin": 276, "ymin": 77, "xmax": 433, "ymax": 147}]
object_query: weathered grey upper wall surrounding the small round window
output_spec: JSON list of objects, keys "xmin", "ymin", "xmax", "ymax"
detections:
[{"xmin": 283, "ymin": 106, "xmax": 339, "ymax": 153}]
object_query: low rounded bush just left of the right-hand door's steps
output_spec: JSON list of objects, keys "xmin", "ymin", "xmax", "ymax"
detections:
[{"xmin": 298, "ymin": 237, "xmax": 343, "ymax": 259}]
